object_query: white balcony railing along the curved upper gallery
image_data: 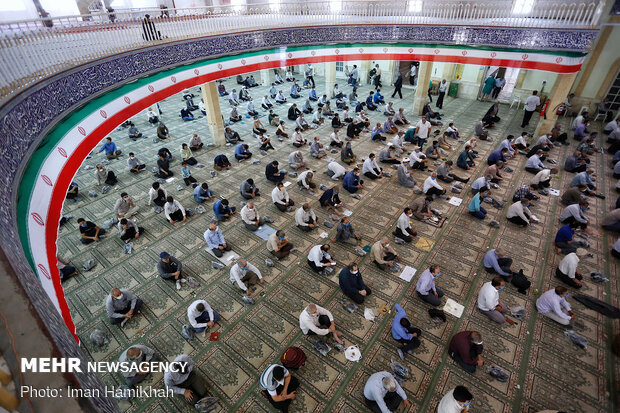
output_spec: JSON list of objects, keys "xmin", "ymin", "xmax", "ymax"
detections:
[{"xmin": 0, "ymin": 0, "xmax": 604, "ymax": 100}]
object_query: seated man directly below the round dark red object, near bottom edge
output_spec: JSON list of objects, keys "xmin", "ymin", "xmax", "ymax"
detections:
[{"xmin": 259, "ymin": 364, "xmax": 299, "ymax": 412}]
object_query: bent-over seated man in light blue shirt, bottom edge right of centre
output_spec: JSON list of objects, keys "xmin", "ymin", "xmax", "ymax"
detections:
[{"xmin": 364, "ymin": 371, "xmax": 411, "ymax": 413}]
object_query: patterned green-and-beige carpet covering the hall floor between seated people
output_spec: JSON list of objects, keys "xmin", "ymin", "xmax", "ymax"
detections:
[{"xmin": 58, "ymin": 73, "xmax": 620, "ymax": 413}]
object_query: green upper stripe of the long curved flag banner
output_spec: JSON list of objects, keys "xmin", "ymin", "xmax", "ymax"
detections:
[{"xmin": 17, "ymin": 43, "xmax": 586, "ymax": 274}]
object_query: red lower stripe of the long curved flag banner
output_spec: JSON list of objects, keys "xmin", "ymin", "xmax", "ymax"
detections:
[{"xmin": 45, "ymin": 52, "xmax": 581, "ymax": 343}]
